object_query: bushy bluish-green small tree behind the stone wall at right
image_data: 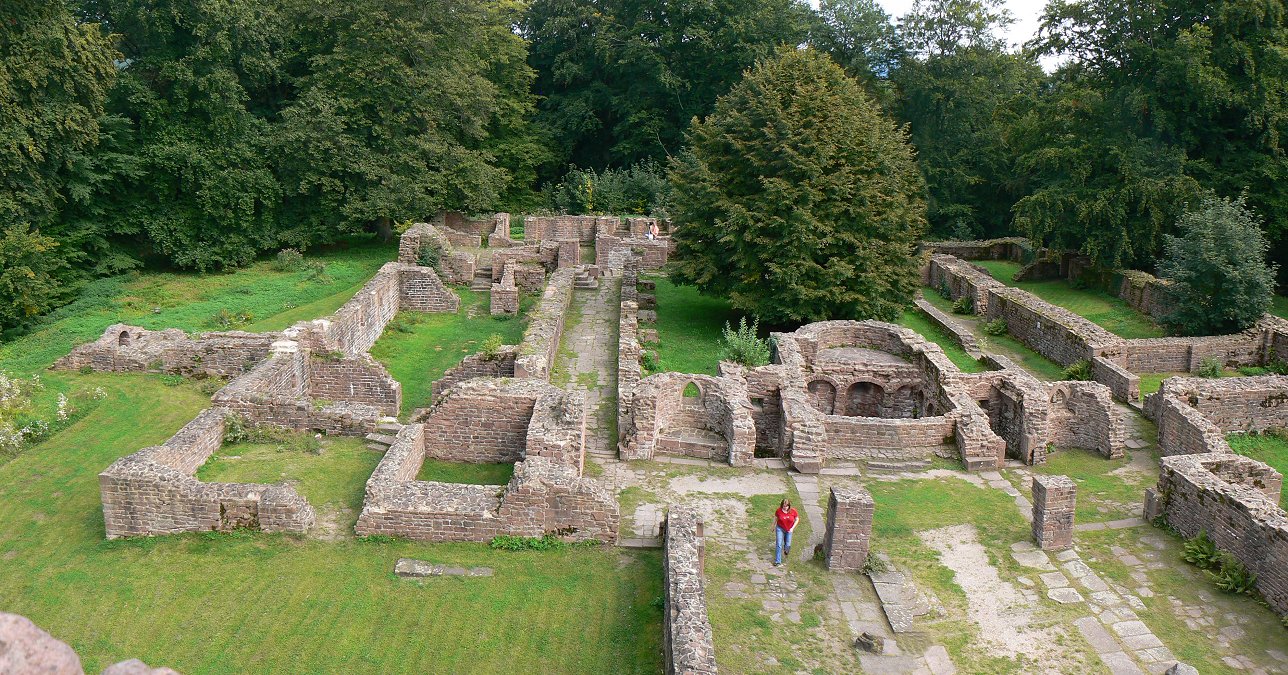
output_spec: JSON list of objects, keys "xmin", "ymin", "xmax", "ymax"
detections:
[{"xmin": 1158, "ymin": 197, "xmax": 1275, "ymax": 335}]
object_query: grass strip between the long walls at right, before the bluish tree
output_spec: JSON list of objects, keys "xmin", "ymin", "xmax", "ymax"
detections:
[{"xmin": 975, "ymin": 260, "xmax": 1167, "ymax": 339}]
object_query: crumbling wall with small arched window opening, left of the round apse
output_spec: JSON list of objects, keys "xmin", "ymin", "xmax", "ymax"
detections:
[{"xmin": 618, "ymin": 372, "xmax": 756, "ymax": 466}]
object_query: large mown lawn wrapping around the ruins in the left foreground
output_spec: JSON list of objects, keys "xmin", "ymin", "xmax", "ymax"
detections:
[{"xmin": 0, "ymin": 374, "xmax": 662, "ymax": 674}]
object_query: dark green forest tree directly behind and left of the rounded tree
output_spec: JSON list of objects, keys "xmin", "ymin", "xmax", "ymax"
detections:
[{"xmin": 523, "ymin": 0, "xmax": 810, "ymax": 169}]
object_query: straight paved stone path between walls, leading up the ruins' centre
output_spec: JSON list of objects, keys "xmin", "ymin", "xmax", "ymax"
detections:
[{"xmin": 555, "ymin": 277, "xmax": 622, "ymax": 462}]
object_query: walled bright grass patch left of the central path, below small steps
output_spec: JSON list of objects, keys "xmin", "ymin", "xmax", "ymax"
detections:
[{"xmin": 371, "ymin": 289, "xmax": 535, "ymax": 416}]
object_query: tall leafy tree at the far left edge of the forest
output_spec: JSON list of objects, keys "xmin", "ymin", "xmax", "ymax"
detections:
[{"xmin": 0, "ymin": 0, "xmax": 117, "ymax": 328}]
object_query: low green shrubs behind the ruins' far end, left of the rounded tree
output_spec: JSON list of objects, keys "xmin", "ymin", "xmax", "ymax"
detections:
[{"xmin": 545, "ymin": 160, "xmax": 671, "ymax": 218}]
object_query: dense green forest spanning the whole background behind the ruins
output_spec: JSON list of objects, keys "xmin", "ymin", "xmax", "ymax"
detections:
[{"xmin": 0, "ymin": 0, "xmax": 1288, "ymax": 330}]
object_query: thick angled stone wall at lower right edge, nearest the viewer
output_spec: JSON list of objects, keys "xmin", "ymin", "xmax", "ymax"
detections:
[{"xmin": 1146, "ymin": 455, "xmax": 1288, "ymax": 613}]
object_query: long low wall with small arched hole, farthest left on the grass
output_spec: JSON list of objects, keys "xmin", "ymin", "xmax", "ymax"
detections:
[{"xmin": 54, "ymin": 323, "xmax": 279, "ymax": 377}]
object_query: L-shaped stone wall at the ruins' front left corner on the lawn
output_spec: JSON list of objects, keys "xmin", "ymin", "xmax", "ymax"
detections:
[{"xmin": 99, "ymin": 410, "xmax": 314, "ymax": 538}]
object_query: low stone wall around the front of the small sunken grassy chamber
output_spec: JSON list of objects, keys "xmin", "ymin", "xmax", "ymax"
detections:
[{"xmin": 355, "ymin": 424, "xmax": 620, "ymax": 544}]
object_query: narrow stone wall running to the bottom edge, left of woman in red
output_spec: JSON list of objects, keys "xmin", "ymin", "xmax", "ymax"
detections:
[{"xmin": 662, "ymin": 506, "xmax": 717, "ymax": 675}]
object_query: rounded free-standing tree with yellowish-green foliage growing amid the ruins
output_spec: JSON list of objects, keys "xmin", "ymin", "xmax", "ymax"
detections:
[{"xmin": 671, "ymin": 48, "xmax": 925, "ymax": 323}]
